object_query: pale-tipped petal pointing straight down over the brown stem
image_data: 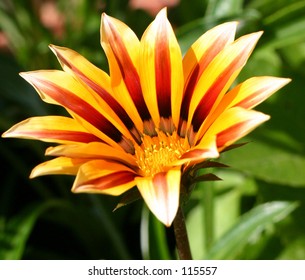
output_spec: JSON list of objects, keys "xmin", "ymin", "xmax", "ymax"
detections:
[{"xmin": 135, "ymin": 167, "xmax": 181, "ymax": 227}]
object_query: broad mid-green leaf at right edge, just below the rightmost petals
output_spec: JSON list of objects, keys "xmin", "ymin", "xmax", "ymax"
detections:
[{"xmin": 222, "ymin": 130, "xmax": 305, "ymax": 187}]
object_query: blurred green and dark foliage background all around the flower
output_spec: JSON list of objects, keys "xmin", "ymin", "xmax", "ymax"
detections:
[{"xmin": 0, "ymin": 0, "xmax": 305, "ymax": 259}]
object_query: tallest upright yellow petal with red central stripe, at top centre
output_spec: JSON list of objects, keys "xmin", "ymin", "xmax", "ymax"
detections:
[{"xmin": 140, "ymin": 9, "xmax": 183, "ymax": 133}]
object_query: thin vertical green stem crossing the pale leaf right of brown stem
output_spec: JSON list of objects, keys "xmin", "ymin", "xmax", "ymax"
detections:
[{"xmin": 203, "ymin": 182, "xmax": 214, "ymax": 251}]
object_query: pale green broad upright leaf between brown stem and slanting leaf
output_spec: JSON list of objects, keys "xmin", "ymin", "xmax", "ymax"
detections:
[{"xmin": 186, "ymin": 179, "xmax": 244, "ymax": 259}]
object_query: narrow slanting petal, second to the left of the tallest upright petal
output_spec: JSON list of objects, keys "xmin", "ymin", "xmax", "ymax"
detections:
[{"xmin": 50, "ymin": 45, "xmax": 140, "ymax": 144}]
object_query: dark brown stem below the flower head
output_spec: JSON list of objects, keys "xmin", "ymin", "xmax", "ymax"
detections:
[{"xmin": 173, "ymin": 206, "xmax": 192, "ymax": 260}]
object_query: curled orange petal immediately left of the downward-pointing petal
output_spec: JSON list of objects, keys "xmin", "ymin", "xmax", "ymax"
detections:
[{"xmin": 72, "ymin": 160, "xmax": 136, "ymax": 195}]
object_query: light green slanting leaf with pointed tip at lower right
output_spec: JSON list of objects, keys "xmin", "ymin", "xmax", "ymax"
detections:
[{"xmin": 206, "ymin": 201, "xmax": 298, "ymax": 259}]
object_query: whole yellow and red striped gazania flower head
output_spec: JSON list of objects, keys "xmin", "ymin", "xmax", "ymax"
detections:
[{"xmin": 4, "ymin": 9, "xmax": 289, "ymax": 226}]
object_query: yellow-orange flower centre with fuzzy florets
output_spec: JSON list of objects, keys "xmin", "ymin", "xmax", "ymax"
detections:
[{"xmin": 135, "ymin": 131, "xmax": 189, "ymax": 176}]
